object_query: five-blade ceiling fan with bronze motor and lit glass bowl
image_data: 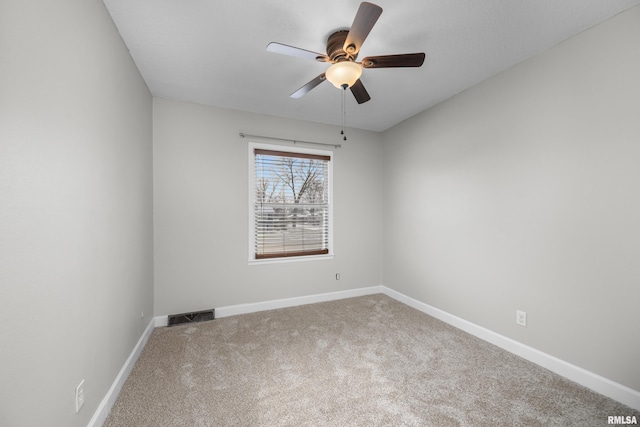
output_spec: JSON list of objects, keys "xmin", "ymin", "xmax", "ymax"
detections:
[{"xmin": 267, "ymin": 2, "xmax": 425, "ymax": 104}]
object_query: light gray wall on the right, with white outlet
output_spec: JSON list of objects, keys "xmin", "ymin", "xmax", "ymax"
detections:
[{"xmin": 383, "ymin": 7, "xmax": 640, "ymax": 390}]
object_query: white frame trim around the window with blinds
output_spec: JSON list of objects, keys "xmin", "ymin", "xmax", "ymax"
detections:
[{"xmin": 248, "ymin": 142, "xmax": 334, "ymax": 265}]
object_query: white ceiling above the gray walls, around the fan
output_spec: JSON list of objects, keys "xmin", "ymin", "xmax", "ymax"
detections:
[{"xmin": 104, "ymin": 0, "xmax": 640, "ymax": 131}]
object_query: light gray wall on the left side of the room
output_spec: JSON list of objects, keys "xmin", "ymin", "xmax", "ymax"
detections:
[{"xmin": 0, "ymin": 0, "xmax": 153, "ymax": 427}]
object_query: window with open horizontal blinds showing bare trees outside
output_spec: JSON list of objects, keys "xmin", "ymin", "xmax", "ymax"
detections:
[{"xmin": 249, "ymin": 144, "xmax": 332, "ymax": 261}]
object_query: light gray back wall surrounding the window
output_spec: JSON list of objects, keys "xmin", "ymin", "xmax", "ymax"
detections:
[{"xmin": 153, "ymin": 99, "xmax": 382, "ymax": 314}]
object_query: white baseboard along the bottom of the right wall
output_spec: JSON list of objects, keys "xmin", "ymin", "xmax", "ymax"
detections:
[{"xmin": 381, "ymin": 286, "xmax": 640, "ymax": 410}]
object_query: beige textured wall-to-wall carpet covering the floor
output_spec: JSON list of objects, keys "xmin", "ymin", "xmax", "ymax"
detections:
[{"xmin": 105, "ymin": 295, "xmax": 640, "ymax": 427}]
